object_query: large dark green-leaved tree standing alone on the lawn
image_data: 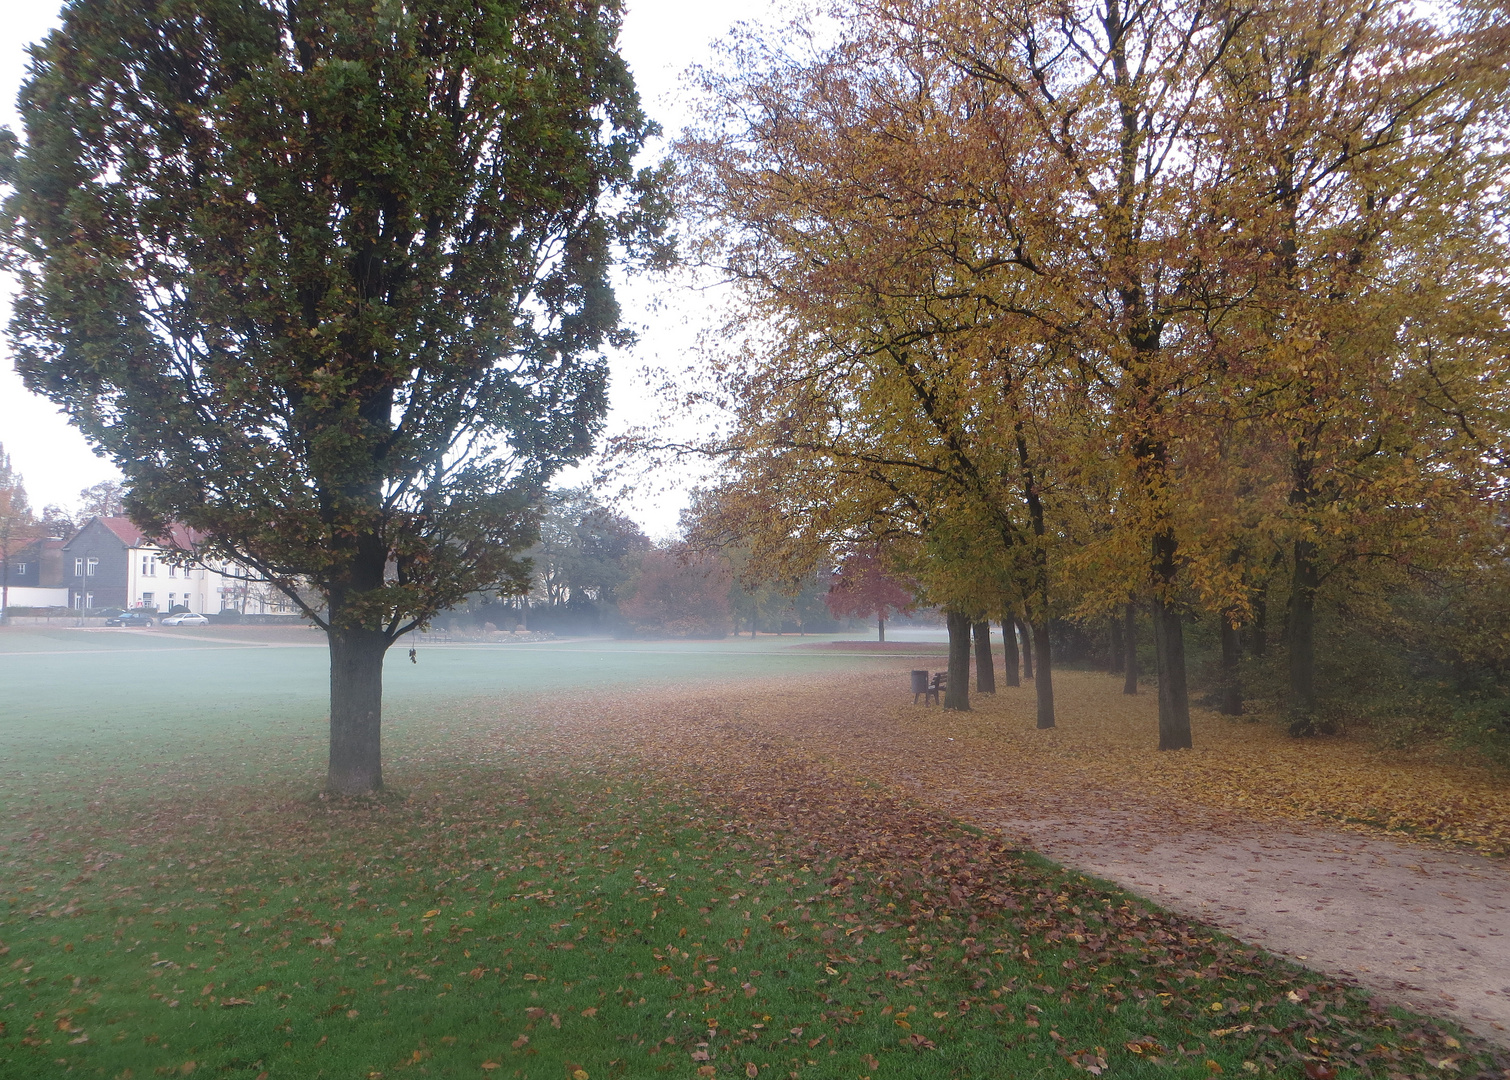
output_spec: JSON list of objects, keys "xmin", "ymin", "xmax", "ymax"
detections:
[{"xmin": 6, "ymin": 0, "xmax": 667, "ymax": 793}]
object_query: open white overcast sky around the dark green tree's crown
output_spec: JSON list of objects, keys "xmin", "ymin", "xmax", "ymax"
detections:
[{"xmin": 0, "ymin": 0, "xmax": 776, "ymax": 536}]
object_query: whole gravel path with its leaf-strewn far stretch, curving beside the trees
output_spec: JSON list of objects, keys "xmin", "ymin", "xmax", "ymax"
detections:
[{"xmin": 691, "ymin": 672, "xmax": 1510, "ymax": 1045}]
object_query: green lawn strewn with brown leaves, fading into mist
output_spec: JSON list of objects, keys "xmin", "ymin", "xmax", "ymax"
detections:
[{"xmin": 0, "ymin": 628, "xmax": 1492, "ymax": 1080}]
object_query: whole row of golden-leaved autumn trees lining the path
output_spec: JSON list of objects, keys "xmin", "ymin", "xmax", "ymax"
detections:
[{"xmin": 678, "ymin": 0, "xmax": 1510, "ymax": 748}]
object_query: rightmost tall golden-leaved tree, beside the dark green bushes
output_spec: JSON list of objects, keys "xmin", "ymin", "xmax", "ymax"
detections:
[{"xmin": 1214, "ymin": 0, "xmax": 1510, "ymax": 731}]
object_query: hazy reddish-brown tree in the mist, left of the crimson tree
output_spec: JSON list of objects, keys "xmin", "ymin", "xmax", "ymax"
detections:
[{"xmin": 619, "ymin": 548, "xmax": 734, "ymax": 637}]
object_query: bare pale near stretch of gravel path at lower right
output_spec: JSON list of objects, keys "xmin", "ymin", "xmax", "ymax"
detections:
[{"xmin": 972, "ymin": 809, "xmax": 1510, "ymax": 1045}]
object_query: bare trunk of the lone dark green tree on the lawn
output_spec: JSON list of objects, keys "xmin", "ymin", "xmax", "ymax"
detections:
[{"xmin": 325, "ymin": 625, "xmax": 390, "ymax": 795}]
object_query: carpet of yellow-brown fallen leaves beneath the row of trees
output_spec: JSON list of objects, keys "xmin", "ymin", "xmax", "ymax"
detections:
[{"xmin": 691, "ymin": 660, "xmax": 1510, "ymax": 855}]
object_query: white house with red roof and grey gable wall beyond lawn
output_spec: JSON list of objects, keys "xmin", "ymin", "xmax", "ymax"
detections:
[{"xmin": 62, "ymin": 517, "xmax": 294, "ymax": 615}]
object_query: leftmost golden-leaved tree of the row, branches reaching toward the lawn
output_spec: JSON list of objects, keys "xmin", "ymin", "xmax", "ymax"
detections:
[{"xmin": 680, "ymin": 21, "xmax": 1083, "ymax": 724}]
